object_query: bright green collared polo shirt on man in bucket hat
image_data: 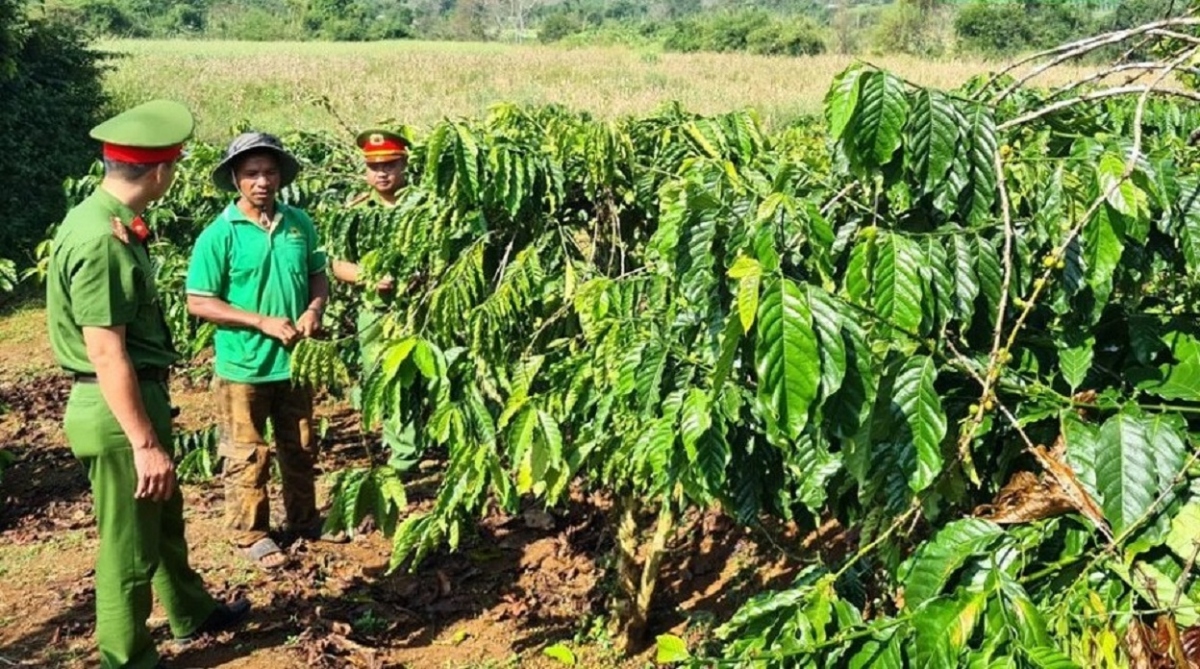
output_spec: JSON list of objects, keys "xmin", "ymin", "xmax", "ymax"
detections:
[{"xmin": 187, "ymin": 204, "xmax": 325, "ymax": 384}]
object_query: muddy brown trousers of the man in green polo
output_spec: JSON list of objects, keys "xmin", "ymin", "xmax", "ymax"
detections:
[{"xmin": 214, "ymin": 378, "xmax": 320, "ymax": 547}]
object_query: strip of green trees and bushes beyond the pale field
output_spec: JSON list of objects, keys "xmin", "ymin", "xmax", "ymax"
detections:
[{"xmin": 25, "ymin": 0, "xmax": 1183, "ymax": 55}]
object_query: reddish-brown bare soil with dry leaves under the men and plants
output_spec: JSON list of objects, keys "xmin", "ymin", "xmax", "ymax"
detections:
[{"xmin": 0, "ymin": 308, "xmax": 799, "ymax": 669}]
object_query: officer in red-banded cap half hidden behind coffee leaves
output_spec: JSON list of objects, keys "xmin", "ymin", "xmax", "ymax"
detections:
[{"xmin": 331, "ymin": 128, "xmax": 409, "ymax": 369}]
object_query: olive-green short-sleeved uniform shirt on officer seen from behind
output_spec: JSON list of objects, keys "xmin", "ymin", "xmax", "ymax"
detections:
[{"xmin": 46, "ymin": 188, "xmax": 179, "ymax": 373}]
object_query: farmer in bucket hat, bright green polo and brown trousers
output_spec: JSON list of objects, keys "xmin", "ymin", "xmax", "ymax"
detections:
[{"xmin": 187, "ymin": 132, "xmax": 344, "ymax": 568}]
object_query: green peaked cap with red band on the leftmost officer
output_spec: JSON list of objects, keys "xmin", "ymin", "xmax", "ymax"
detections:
[{"xmin": 91, "ymin": 100, "xmax": 196, "ymax": 163}]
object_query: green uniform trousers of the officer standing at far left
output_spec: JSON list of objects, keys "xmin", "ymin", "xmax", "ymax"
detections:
[{"xmin": 64, "ymin": 381, "xmax": 216, "ymax": 669}]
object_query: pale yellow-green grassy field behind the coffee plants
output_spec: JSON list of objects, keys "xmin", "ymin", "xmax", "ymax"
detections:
[{"xmin": 100, "ymin": 41, "xmax": 1099, "ymax": 140}]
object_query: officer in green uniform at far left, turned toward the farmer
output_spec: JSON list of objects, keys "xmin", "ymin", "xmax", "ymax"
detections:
[{"xmin": 47, "ymin": 101, "xmax": 250, "ymax": 669}]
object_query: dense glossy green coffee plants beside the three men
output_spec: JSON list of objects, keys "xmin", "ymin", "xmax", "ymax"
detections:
[{"xmin": 44, "ymin": 10, "xmax": 1200, "ymax": 668}]
